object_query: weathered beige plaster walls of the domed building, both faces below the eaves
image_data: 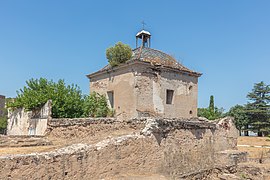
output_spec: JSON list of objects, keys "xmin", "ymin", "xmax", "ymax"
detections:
[{"xmin": 90, "ymin": 63, "xmax": 198, "ymax": 119}]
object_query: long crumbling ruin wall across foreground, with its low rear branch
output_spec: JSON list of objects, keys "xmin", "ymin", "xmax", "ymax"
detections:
[{"xmin": 0, "ymin": 118, "xmax": 245, "ymax": 179}]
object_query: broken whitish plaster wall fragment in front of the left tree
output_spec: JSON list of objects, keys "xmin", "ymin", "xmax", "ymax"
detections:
[{"xmin": 7, "ymin": 101, "xmax": 51, "ymax": 136}]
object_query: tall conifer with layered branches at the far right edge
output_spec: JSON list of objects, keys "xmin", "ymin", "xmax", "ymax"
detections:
[{"xmin": 246, "ymin": 81, "xmax": 270, "ymax": 136}]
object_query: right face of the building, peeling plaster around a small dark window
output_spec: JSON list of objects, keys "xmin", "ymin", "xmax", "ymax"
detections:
[{"xmin": 135, "ymin": 66, "xmax": 198, "ymax": 118}]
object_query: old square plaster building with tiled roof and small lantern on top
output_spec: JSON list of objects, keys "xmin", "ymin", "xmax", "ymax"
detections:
[{"xmin": 87, "ymin": 30, "xmax": 201, "ymax": 118}]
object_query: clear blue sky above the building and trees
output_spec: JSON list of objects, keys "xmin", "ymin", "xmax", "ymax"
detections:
[{"xmin": 0, "ymin": 0, "xmax": 270, "ymax": 110}]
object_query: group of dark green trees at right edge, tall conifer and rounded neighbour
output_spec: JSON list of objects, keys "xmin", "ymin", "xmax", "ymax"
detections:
[{"xmin": 226, "ymin": 81, "xmax": 270, "ymax": 136}]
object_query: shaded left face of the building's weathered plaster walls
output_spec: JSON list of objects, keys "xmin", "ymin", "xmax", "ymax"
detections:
[{"xmin": 90, "ymin": 66, "xmax": 137, "ymax": 119}]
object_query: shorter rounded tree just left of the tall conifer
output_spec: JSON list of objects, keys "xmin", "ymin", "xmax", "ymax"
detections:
[{"xmin": 226, "ymin": 104, "xmax": 249, "ymax": 136}]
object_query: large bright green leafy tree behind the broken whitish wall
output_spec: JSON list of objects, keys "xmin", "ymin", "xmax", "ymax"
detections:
[{"xmin": 8, "ymin": 78, "xmax": 84, "ymax": 118}]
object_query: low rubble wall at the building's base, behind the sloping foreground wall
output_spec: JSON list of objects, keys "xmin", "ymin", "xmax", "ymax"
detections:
[{"xmin": 46, "ymin": 118, "xmax": 146, "ymax": 139}]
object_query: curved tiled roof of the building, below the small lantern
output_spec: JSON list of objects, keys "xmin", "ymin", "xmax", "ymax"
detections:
[{"xmin": 90, "ymin": 47, "xmax": 201, "ymax": 76}]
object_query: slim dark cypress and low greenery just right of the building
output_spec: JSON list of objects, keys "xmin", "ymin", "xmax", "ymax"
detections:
[{"xmin": 198, "ymin": 96, "xmax": 224, "ymax": 120}]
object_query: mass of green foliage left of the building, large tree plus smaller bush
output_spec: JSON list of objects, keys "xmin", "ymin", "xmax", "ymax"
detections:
[{"xmin": 8, "ymin": 78, "xmax": 108, "ymax": 118}]
